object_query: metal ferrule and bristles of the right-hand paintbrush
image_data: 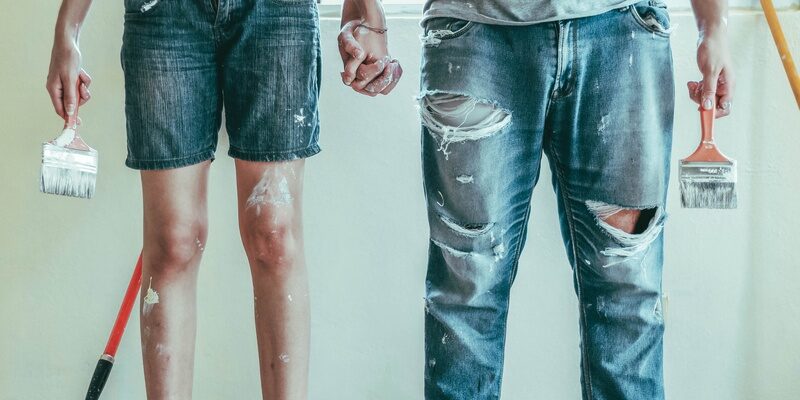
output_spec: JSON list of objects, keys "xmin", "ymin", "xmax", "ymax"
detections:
[{"xmin": 680, "ymin": 160, "xmax": 737, "ymax": 209}]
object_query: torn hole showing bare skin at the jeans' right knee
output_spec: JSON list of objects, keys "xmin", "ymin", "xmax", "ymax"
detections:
[{"xmin": 586, "ymin": 200, "xmax": 664, "ymax": 257}]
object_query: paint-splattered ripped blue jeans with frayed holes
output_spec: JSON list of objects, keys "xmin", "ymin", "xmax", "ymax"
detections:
[{"xmin": 419, "ymin": 1, "xmax": 674, "ymax": 400}]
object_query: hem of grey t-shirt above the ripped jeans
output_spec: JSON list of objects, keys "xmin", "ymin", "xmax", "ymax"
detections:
[{"xmin": 422, "ymin": 0, "xmax": 641, "ymax": 25}]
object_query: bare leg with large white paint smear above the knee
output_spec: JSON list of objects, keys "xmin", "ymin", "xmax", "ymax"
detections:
[{"xmin": 236, "ymin": 160, "xmax": 309, "ymax": 400}]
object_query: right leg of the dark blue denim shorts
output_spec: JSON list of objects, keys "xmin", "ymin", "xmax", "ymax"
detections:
[{"xmin": 223, "ymin": 0, "xmax": 321, "ymax": 162}]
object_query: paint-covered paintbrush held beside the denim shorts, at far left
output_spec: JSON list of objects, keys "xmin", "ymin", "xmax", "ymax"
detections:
[{"xmin": 40, "ymin": 81, "xmax": 98, "ymax": 199}]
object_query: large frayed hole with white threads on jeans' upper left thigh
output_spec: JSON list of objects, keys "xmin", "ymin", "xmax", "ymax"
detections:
[{"xmin": 419, "ymin": 92, "xmax": 511, "ymax": 159}]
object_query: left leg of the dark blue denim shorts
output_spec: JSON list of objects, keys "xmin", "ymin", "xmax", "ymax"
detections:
[{"xmin": 121, "ymin": 0, "xmax": 221, "ymax": 169}]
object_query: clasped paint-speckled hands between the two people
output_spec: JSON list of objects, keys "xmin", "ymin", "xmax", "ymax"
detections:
[{"xmin": 339, "ymin": 19, "xmax": 403, "ymax": 97}]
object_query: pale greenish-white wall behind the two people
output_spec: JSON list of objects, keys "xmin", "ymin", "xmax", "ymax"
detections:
[{"xmin": 0, "ymin": 0, "xmax": 800, "ymax": 400}]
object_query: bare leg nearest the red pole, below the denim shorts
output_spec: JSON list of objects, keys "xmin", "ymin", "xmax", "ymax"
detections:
[{"xmin": 140, "ymin": 162, "xmax": 210, "ymax": 400}]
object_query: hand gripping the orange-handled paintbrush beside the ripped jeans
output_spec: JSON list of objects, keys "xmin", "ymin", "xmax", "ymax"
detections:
[{"xmin": 688, "ymin": 25, "xmax": 736, "ymax": 118}]
